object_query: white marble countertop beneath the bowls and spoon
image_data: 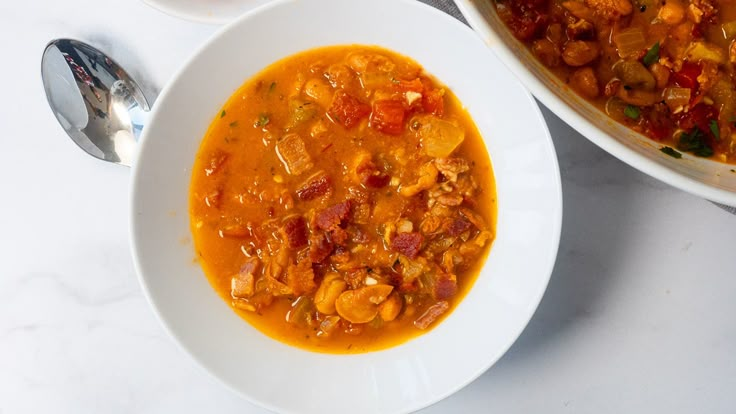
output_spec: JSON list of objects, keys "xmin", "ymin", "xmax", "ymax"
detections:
[{"xmin": 0, "ymin": 0, "xmax": 736, "ymax": 414}]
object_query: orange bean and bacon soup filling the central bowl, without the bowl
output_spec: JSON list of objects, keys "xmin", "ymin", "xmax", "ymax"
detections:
[{"xmin": 190, "ymin": 46, "xmax": 496, "ymax": 353}]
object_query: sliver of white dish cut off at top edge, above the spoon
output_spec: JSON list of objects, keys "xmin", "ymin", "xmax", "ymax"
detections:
[{"xmin": 143, "ymin": 0, "xmax": 271, "ymax": 24}]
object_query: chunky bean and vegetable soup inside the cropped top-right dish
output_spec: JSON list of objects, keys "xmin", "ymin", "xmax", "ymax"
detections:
[{"xmin": 495, "ymin": 0, "xmax": 736, "ymax": 163}]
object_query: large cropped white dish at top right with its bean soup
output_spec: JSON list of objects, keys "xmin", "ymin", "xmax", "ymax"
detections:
[{"xmin": 456, "ymin": 0, "xmax": 736, "ymax": 205}]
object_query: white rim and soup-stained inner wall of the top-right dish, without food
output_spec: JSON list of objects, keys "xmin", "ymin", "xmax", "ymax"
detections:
[{"xmin": 455, "ymin": 0, "xmax": 736, "ymax": 206}]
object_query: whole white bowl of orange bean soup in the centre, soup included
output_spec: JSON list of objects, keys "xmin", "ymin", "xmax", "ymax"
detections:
[{"xmin": 131, "ymin": 0, "xmax": 562, "ymax": 413}]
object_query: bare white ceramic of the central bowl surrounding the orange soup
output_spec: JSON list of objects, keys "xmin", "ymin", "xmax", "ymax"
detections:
[{"xmin": 131, "ymin": 0, "xmax": 562, "ymax": 414}]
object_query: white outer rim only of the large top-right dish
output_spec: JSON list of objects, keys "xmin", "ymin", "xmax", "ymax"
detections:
[{"xmin": 454, "ymin": 0, "xmax": 736, "ymax": 206}]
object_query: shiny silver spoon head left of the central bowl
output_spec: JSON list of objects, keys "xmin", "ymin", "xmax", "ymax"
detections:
[{"xmin": 41, "ymin": 39, "xmax": 150, "ymax": 166}]
